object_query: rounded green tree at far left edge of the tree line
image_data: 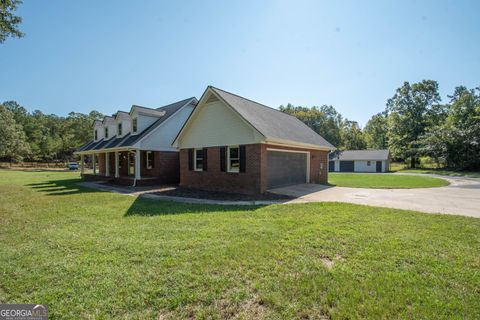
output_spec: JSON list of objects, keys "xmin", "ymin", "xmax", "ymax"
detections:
[{"xmin": 0, "ymin": 105, "xmax": 29, "ymax": 161}]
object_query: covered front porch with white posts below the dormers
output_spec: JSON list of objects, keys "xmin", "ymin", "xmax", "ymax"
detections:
[{"xmin": 80, "ymin": 149, "xmax": 179, "ymax": 186}]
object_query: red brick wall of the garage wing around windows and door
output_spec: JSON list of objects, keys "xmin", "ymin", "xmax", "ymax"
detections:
[{"xmin": 180, "ymin": 144, "xmax": 328, "ymax": 194}]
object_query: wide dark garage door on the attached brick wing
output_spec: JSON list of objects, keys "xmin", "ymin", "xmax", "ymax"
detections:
[{"xmin": 267, "ymin": 151, "xmax": 307, "ymax": 189}]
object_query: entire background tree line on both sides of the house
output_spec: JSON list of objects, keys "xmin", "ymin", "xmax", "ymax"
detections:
[{"xmin": 0, "ymin": 80, "xmax": 480, "ymax": 170}]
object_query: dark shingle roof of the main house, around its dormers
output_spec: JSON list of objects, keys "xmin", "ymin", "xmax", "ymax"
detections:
[{"xmin": 77, "ymin": 97, "xmax": 197, "ymax": 152}]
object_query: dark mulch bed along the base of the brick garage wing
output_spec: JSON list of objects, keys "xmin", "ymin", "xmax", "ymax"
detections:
[{"xmin": 155, "ymin": 187, "xmax": 293, "ymax": 201}]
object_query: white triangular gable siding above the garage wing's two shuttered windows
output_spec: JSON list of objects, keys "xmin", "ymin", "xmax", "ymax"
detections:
[{"xmin": 178, "ymin": 101, "xmax": 264, "ymax": 149}]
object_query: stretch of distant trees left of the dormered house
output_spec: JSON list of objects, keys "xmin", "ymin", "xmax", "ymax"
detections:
[{"xmin": 0, "ymin": 101, "xmax": 103, "ymax": 161}]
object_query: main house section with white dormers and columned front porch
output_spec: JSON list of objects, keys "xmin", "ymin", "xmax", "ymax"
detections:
[{"xmin": 75, "ymin": 97, "xmax": 198, "ymax": 185}]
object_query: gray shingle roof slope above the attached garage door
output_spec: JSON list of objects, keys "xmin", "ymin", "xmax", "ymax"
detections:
[{"xmin": 210, "ymin": 87, "xmax": 335, "ymax": 149}]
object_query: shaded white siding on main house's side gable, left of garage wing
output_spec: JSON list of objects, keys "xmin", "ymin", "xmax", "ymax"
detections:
[{"xmin": 140, "ymin": 104, "xmax": 193, "ymax": 151}]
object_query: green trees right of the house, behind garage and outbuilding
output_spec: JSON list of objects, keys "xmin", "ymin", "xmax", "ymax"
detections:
[{"xmin": 280, "ymin": 80, "xmax": 480, "ymax": 170}]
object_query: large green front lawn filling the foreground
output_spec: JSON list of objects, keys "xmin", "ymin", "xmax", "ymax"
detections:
[{"xmin": 0, "ymin": 170, "xmax": 480, "ymax": 319}]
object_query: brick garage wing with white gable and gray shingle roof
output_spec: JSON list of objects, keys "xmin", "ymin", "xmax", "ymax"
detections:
[{"xmin": 172, "ymin": 86, "xmax": 334, "ymax": 194}]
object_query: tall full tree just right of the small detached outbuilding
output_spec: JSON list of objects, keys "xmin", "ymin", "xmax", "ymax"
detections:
[{"xmin": 386, "ymin": 80, "xmax": 440, "ymax": 168}]
